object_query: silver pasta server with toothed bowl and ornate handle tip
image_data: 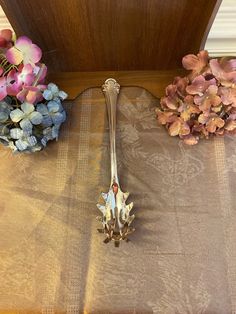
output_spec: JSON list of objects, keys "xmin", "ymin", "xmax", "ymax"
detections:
[{"xmin": 97, "ymin": 78, "xmax": 135, "ymax": 247}]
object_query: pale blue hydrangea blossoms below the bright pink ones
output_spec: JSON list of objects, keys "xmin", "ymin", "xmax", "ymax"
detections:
[{"xmin": 0, "ymin": 83, "xmax": 67, "ymax": 152}]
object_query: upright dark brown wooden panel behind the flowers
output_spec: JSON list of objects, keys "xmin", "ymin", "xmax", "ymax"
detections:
[{"xmin": 0, "ymin": 0, "xmax": 220, "ymax": 71}]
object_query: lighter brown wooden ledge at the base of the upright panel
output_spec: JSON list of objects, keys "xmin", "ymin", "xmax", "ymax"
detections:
[{"xmin": 48, "ymin": 69, "xmax": 185, "ymax": 99}]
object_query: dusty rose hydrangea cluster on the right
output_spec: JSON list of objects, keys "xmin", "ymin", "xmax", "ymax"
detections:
[{"xmin": 156, "ymin": 50, "xmax": 236, "ymax": 145}]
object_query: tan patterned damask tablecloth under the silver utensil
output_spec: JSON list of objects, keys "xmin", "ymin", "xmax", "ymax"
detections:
[{"xmin": 0, "ymin": 87, "xmax": 236, "ymax": 314}]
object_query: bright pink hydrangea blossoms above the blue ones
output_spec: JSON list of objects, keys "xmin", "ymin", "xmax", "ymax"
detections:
[{"xmin": 0, "ymin": 30, "xmax": 47, "ymax": 104}]
